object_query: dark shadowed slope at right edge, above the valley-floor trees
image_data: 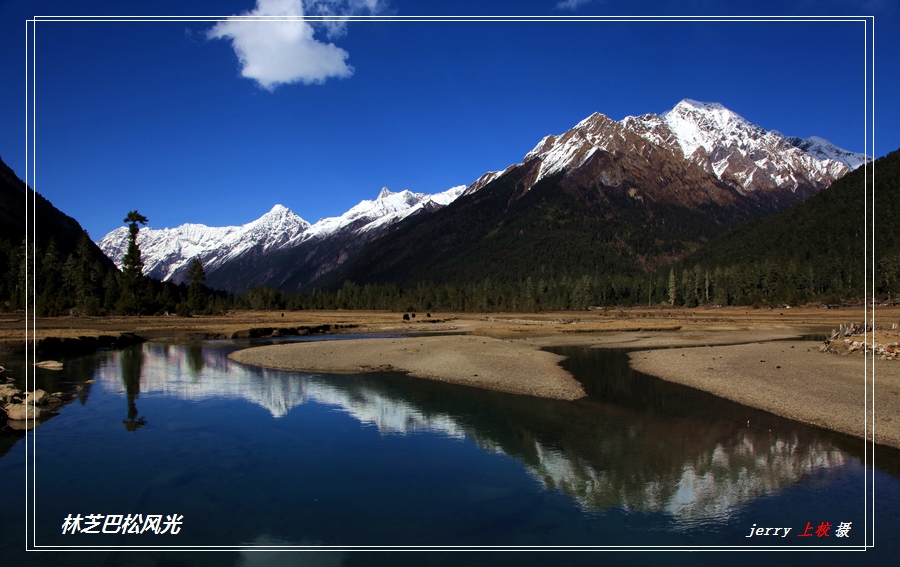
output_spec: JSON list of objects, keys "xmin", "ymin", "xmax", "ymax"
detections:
[{"xmin": 681, "ymin": 150, "xmax": 900, "ymax": 297}]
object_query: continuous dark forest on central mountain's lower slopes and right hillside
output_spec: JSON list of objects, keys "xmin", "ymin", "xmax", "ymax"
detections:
[{"xmin": 296, "ymin": 151, "xmax": 900, "ymax": 310}]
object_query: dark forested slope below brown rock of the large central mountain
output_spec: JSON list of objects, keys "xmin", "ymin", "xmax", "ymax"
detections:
[{"xmin": 318, "ymin": 159, "xmax": 764, "ymax": 287}]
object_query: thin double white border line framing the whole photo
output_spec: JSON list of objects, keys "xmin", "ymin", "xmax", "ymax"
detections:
[{"xmin": 26, "ymin": 16, "xmax": 875, "ymax": 551}]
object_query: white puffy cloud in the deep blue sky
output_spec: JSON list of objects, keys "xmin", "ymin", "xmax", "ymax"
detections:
[{"xmin": 207, "ymin": 0, "xmax": 381, "ymax": 91}]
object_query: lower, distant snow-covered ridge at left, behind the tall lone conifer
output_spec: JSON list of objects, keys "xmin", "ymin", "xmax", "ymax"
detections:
[{"xmin": 97, "ymin": 186, "xmax": 465, "ymax": 283}]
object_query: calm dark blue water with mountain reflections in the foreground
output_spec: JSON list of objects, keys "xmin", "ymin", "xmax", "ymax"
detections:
[{"xmin": 0, "ymin": 338, "xmax": 900, "ymax": 565}]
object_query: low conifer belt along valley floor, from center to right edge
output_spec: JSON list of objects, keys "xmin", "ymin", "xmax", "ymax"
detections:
[{"xmin": 233, "ymin": 254, "xmax": 884, "ymax": 312}]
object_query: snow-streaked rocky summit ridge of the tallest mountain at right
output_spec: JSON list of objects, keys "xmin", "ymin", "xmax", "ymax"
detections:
[{"xmin": 524, "ymin": 99, "xmax": 871, "ymax": 199}]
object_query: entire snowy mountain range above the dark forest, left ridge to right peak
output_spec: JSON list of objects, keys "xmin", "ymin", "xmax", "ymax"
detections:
[{"xmin": 98, "ymin": 99, "xmax": 871, "ymax": 291}]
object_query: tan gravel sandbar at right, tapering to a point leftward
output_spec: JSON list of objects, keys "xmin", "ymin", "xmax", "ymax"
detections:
[{"xmin": 629, "ymin": 341, "xmax": 900, "ymax": 448}]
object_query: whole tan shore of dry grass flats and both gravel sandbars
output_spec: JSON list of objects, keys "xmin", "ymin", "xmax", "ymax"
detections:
[{"xmin": 7, "ymin": 307, "xmax": 900, "ymax": 449}]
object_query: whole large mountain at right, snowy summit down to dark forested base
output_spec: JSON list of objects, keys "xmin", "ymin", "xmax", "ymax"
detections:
[{"xmin": 323, "ymin": 100, "xmax": 872, "ymax": 286}]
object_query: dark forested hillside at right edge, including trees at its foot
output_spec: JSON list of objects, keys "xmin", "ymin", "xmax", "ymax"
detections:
[{"xmin": 675, "ymin": 150, "xmax": 900, "ymax": 302}]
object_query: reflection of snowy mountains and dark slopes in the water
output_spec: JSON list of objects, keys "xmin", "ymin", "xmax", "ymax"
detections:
[{"xmin": 82, "ymin": 343, "xmax": 852, "ymax": 529}]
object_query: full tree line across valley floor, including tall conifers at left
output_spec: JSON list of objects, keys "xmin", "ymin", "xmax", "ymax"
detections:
[{"xmin": 0, "ymin": 240, "xmax": 884, "ymax": 317}]
